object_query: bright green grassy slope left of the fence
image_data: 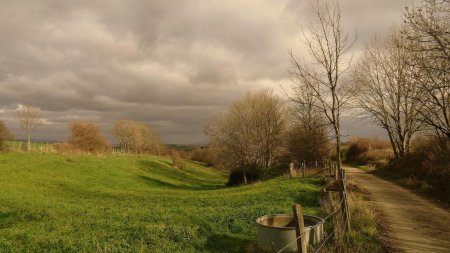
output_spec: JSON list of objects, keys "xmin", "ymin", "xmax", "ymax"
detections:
[{"xmin": 0, "ymin": 153, "xmax": 320, "ymax": 252}]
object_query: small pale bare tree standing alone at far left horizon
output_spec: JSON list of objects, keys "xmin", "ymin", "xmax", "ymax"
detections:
[{"xmin": 17, "ymin": 105, "xmax": 44, "ymax": 150}]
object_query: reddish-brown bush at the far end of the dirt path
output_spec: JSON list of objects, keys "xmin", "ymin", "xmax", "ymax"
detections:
[{"xmin": 346, "ymin": 138, "xmax": 393, "ymax": 165}]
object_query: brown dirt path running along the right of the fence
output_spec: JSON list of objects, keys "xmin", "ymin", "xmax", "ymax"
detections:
[{"xmin": 345, "ymin": 167, "xmax": 450, "ymax": 253}]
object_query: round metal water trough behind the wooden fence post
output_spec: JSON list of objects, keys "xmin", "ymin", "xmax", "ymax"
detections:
[{"xmin": 256, "ymin": 214, "xmax": 324, "ymax": 252}]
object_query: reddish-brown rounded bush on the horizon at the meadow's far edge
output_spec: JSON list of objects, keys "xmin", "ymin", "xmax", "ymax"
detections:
[{"xmin": 65, "ymin": 121, "xmax": 111, "ymax": 154}]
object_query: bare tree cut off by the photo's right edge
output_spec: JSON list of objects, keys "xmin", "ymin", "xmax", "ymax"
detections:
[{"xmin": 403, "ymin": 0, "xmax": 450, "ymax": 140}]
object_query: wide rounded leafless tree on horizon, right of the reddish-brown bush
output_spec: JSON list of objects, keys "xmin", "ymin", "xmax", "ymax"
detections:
[{"xmin": 113, "ymin": 120, "xmax": 161, "ymax": 154}]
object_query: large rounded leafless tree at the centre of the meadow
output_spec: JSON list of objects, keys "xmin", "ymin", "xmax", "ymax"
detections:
[{"xmin": 206, "ymin": 90, "xmax": 286, "ymax": 183}]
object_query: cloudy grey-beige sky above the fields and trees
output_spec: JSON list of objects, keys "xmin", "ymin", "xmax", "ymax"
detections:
[{"xmin": 0, "ymin": 0, "xmax": 412, "ymax": 144}]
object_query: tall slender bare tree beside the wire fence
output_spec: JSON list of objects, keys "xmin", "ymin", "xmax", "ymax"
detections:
[{"xmin": 290, "ymin": 0, "xmax": 356, "ymax": 170}]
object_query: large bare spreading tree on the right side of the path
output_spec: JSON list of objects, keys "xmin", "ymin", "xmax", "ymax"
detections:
[{"xmin": 353, "ymin": 31, "xmax": 423, "ymax": 159}]
